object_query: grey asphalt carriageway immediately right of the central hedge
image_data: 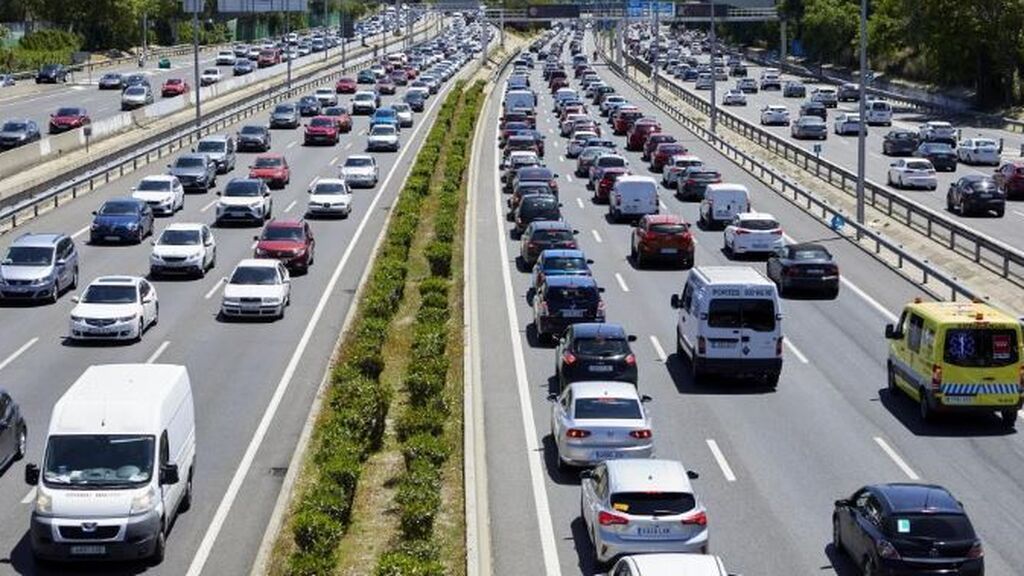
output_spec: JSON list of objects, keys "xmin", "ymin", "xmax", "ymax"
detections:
[{"xmin": 467, "ymin": 31, "xmax": 1024, "ymax": 576}]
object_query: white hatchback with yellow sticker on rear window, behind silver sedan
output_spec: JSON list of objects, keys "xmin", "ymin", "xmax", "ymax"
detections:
[{"xmin": 580, "ymin": 458, "xmax": 708, "ymax": 566}]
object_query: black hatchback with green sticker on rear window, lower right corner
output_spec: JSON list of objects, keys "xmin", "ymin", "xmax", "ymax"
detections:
[{"xmin": 833, "ymin": 484, "xmax": 985, "ymax": 576}]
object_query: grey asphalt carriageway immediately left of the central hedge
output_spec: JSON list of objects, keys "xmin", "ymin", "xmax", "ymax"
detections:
[{"xmin": 0, "ymin": 22, "xmax": 468, "ymax": 576}]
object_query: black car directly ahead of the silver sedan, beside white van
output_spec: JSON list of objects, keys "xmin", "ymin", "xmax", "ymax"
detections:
[{"xmin": 555, "ymin": 322, "xmax": 637, "ymax": 392}]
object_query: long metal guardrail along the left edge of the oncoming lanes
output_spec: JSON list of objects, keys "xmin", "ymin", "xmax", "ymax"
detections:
[{"xmin": 0, "ymin": 25, "xmax": 430, "ymax": 234}]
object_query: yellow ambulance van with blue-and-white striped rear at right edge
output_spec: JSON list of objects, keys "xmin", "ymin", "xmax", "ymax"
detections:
[{"xmin": 886, "ymin": 299, "xmax": 1024, "ymax": 428}]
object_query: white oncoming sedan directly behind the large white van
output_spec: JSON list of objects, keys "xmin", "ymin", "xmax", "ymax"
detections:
[{"xmin": 69, "ymin": 276, "xmax": 160, "ymax": 341}]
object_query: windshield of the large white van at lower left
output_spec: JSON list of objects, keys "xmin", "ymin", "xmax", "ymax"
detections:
[{"xmin": 43, "ymin": 435, "xmax": 155, "ymax": 489}]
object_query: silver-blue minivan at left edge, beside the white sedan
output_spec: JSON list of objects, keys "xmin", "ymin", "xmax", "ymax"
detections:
[{"xmin": 0, "ymin": 233, "xmax": 78, "ymax": 305}]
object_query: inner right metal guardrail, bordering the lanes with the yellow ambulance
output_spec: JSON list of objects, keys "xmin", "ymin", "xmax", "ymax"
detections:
[{"xmin": 608, "ymin": 56, "xmax": 982, "ymax": 300}]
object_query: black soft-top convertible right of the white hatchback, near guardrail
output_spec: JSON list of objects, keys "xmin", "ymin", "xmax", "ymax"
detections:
[{"xmin": 768, "ymin": 244, "xmax": 839, "ymax": 298}]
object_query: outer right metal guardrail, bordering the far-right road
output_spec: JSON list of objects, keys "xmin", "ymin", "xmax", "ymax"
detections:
[{"xmin": 631, "ymin": 54, "xmax": 1024, "ymax": 284}]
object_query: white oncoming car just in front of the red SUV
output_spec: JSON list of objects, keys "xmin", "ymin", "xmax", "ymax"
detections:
[{"xmin": 220, "ymin": 258, "xmax": 292, "ymax": 319}]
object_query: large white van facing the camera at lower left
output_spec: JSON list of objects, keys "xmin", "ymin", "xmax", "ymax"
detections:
[{"xmin": 25, "ymin": 364, "xmax": 196, "ymax": 563}]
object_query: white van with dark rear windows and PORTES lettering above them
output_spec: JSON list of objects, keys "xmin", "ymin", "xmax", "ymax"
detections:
[{"xmin": 672, "ymin": 266, "xmax": 782, "ymax": 388}]
